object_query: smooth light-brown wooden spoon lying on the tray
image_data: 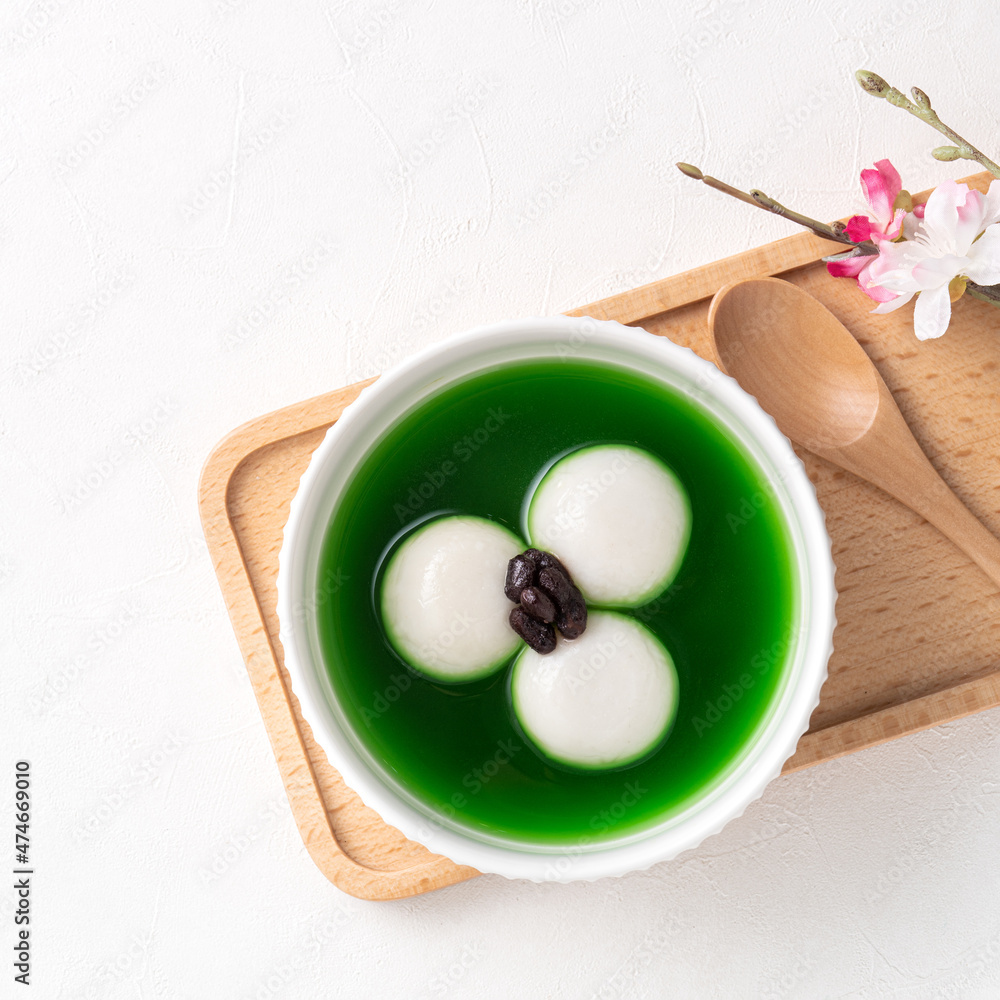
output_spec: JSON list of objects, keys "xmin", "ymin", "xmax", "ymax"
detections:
[{"xmin": 708, "ymin": 278, "xmax": 1000, "ymax": 587}]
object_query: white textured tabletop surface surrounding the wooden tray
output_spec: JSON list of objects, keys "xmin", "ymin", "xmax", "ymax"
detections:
[{"xmin": 0, "ymin": 0, "xmax": 1000, "ymax": 1000}]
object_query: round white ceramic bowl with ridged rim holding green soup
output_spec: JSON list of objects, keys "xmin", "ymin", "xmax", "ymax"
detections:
[{"xmin": 278, "ymin": 316, "xmax": 836, "ymax": 882}]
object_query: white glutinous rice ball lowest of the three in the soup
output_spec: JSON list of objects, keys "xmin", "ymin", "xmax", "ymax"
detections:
[{"xmin": 511, "ymin": 611, "xmax": 678, "ymax": 769}]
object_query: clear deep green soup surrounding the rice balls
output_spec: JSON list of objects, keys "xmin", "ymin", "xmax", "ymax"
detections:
[{"xmin": 316, "ymin": 360, "xmax": 798, "ymax": 847}]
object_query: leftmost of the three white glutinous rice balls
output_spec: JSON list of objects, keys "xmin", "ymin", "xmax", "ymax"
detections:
[{"xmin": 381, "ymin": 516, "xmax": 524, "ymax": 681}]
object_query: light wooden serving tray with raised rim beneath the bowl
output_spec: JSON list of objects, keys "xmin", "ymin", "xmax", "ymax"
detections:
[{"xmin": 199, "ymin": 174, "xmax": 1000, "ymax": 899}]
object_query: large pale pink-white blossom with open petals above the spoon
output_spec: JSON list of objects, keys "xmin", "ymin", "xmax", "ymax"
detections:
[{"xmin": 866, "ymin": 180, "xmax": 1000, "ymax": 340}]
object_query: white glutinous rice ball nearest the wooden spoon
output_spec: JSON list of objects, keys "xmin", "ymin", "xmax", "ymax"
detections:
[{"xmin": 526, "ymin": 445, "xmax": 691, "ymax": 608}]
